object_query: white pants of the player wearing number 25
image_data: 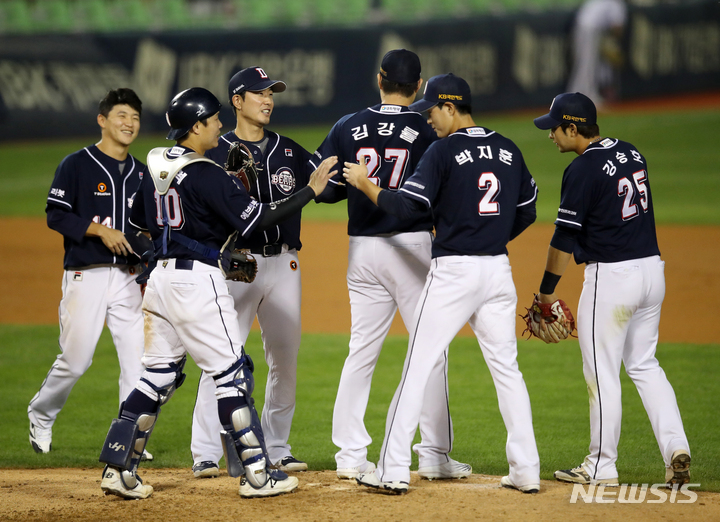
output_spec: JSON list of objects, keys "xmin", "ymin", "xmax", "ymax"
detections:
[{"xmin": 577, "ymin": 256, "xmax": 690, "ymax": 480}]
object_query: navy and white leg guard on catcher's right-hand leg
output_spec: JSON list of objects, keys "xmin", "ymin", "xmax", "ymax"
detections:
[{"xmin": 215, "ymin": 355, "xmax": 287, "ymax": 489}]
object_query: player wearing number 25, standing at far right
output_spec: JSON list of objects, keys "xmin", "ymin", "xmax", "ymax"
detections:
[{"xmin": 535, "ymin": 92, "xmax": 690, "ymax": 486}]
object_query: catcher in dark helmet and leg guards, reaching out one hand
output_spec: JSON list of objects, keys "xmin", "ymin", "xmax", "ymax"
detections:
[{"xmin": 100, "ymin": 87, "xmax": 336, "ymax": 499}]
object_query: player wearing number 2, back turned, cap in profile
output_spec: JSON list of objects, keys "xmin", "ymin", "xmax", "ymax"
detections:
[{"xmin": 344, "ymin": 74, "xmax": 540, "ymax": 493}]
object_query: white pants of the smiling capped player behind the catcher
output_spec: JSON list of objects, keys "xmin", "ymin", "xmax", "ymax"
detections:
[{"xmin": 190, "ymin": 249, "xmax": 302, "ymax": 463}]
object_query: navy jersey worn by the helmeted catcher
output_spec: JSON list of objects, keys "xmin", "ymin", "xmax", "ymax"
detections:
[{"xmin": 130, "ymin": 146, "xmax": 264, "ymax": 266}]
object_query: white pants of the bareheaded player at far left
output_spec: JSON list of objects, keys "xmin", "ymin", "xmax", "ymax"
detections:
[{"xmin": 28, "ymin": 266, "xmax": 144, "ymax": 429}]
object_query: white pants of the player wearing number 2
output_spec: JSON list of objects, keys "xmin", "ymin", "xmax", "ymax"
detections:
[{"xmin": 376, "ymin": 255, "xmax": 540, "ymax": 486}]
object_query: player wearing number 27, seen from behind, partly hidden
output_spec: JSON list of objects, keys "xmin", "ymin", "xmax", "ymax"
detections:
[{"xmin": 313, "ymin": 49, "xmax": 472, "ymax": 479}]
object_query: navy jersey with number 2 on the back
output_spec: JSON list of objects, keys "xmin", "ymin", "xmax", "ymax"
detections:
[{"xmin": 400, "ymin": 127, "xmax": 538, "ymax": 257}]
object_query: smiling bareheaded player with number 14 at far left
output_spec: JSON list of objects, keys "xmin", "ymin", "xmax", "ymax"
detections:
[{"xmin": 28, "ymin": 89, "xmax": 151, "ymax": 458}]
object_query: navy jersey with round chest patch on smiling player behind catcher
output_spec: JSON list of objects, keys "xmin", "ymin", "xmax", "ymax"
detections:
[{"xmin": 205, "ymin": 130, "xmax": 314, "ymax": 250}]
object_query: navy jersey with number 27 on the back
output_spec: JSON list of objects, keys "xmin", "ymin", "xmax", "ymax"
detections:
[{"xmin": 313, "ymin": 104, "xmax": 437, "ymax": 236}]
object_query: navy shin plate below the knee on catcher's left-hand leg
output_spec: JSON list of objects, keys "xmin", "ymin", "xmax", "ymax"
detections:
[{"xmin": 100, "ymin": 400, "xmax": 160, "ymax": 473}]
